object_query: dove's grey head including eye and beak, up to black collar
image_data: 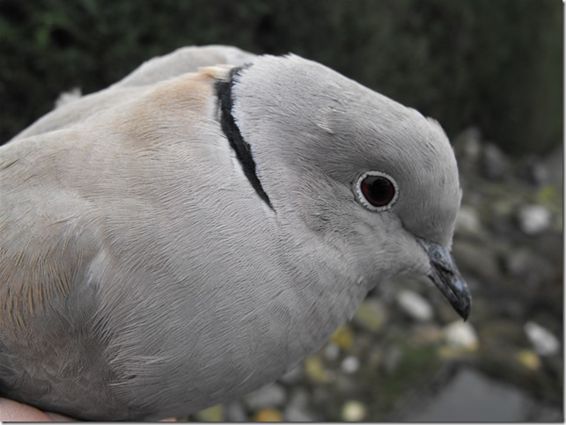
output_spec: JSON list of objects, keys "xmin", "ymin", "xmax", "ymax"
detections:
[{"xmin": 225, "ymin": 55, "xmax": 471, "ymax": 318}]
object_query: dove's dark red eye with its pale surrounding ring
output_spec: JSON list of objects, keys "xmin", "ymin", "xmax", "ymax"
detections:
[{"xmin": 354, "ymin": 171, "xmax": 398, "ymax": 211}]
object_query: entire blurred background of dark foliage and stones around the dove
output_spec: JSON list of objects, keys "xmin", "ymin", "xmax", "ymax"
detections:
[{"xmin": 0, "ymin": 0, "xmax": 563, "ymax": 422}]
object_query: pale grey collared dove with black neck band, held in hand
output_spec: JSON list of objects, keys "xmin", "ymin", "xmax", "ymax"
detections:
[{"xmin": 0, "ymin": 46, "xmax": 471, "ymax": 420}]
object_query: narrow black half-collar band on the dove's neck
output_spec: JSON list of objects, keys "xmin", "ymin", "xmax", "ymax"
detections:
[{"xmin": 216, "ymin": 65, "xmax": 273, "ymax": 210}]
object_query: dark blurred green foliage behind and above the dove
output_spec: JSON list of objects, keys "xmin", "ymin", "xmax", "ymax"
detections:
[{"xmin": 0, "ymin": 0, "xmax": 563, "ymax": 154}]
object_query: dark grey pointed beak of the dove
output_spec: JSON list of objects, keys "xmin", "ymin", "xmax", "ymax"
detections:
[{"xmin": 420, "ymin": 240, "xmax": 472, "ymax": 320}]
